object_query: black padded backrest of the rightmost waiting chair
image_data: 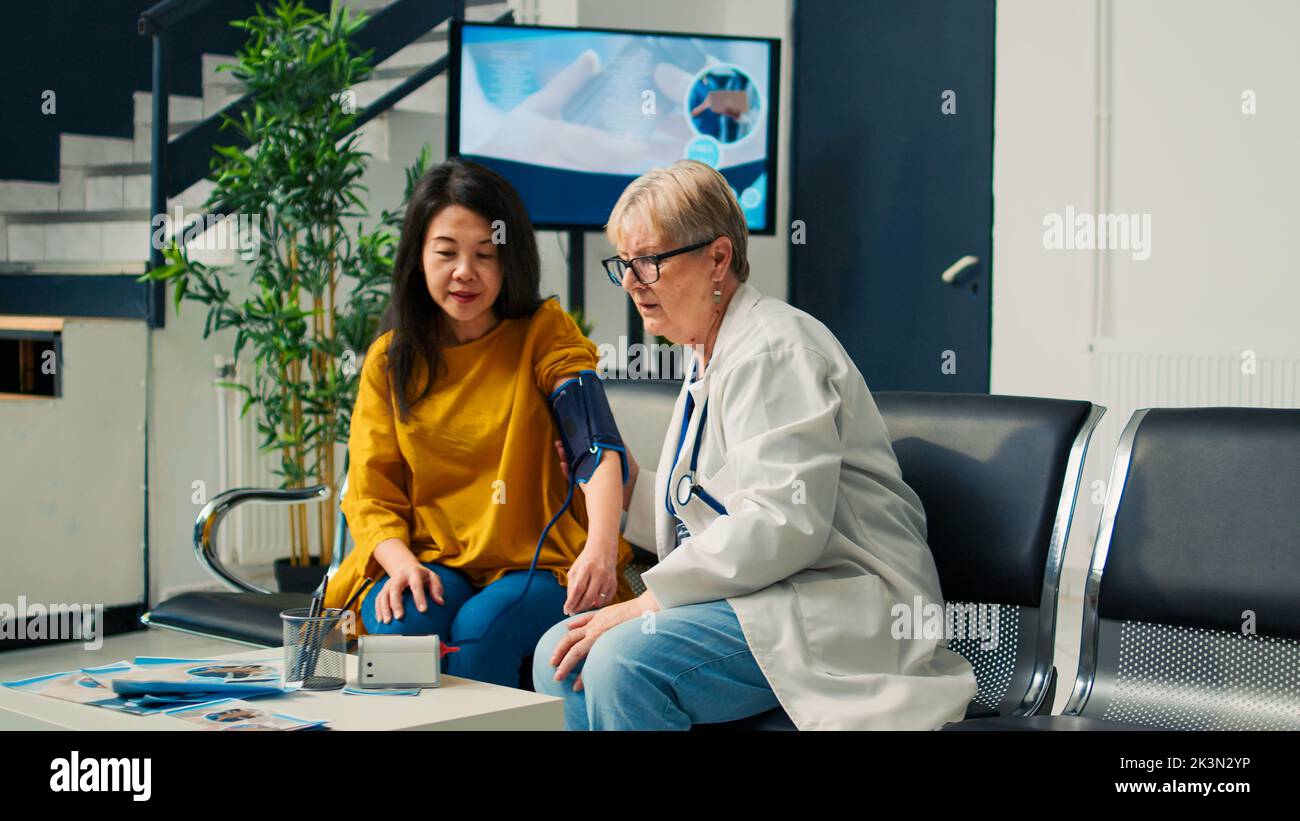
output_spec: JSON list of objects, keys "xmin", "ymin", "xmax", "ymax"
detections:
[{"xmin": 1099, "ymin": 408, "xmax": 1300, "ymax": 639}]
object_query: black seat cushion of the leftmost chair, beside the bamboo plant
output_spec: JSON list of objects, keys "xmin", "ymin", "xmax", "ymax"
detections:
[{"xmin": 148, "ymin": 591, "xmax": 312, "ymax": 647}]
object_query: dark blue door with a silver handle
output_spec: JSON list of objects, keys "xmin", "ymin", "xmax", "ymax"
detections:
[{"xmin": 789, "ymin": 0, "xmax": 995, "ymax": 392}]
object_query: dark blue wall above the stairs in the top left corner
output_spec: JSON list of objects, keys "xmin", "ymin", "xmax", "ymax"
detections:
[{"xmin": 0, "ymin": 0, "xmax": 329, "ymax": 182}]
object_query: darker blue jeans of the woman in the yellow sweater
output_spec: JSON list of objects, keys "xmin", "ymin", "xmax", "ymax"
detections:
[{"xmin": 361, "ymin": 561, "xmax": 568, "ymax": 687}]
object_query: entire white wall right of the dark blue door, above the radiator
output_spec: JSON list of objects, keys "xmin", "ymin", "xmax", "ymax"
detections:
[{"xmin": 992, "ymin": 0, "xmax": 1300, "ymax": 595}]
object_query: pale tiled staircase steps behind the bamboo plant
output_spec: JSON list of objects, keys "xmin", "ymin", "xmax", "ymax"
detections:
[{"xmin": 0, "ymin": 0, "xmax": 508, "ymax": 285}]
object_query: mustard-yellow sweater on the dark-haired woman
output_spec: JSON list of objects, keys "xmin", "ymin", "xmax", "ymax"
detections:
[{"xmin": 325, "ymin": 299, "xmax": 633, "ymax": 633}]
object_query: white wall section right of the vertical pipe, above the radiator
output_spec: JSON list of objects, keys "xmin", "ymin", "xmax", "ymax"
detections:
[{"xmin": 1104, "ymin": 0, "xmax": 1300, "ymax": 355}]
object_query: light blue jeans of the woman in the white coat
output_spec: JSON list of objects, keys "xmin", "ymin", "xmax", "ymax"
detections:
[{"xmin": 533, "ymin": 600, "xmax": 779, "ymax": 730}]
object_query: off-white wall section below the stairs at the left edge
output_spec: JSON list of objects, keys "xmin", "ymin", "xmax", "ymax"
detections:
[{"xmin": 0, "ymin": 320, "xmax": 146, "ymax": 607}]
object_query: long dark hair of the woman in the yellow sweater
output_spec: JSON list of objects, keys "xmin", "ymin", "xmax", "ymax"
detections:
[{"xmin": 378, "ymin": 157, "xmax": 542, "ymax": 421}]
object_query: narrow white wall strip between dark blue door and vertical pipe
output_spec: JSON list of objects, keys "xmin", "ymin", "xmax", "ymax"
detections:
[{"xmin": 991, "ymin": 0, "xmax": 1095, "ymax": 399}]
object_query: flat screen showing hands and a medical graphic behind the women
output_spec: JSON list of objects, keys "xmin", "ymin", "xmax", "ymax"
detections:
[{"xmin": 450, "ymin": 23, "xmax": 777, "ymax": 233}]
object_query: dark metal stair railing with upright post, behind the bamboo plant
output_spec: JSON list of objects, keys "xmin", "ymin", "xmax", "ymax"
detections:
[{"xmin": 139, "ymin": 0, "xmax": 514, "ymax": 327}]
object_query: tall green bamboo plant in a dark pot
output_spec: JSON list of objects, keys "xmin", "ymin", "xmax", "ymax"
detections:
[{"xmin": 142, "ymin": 0, "xmax": 429, "ymax": 591}]
